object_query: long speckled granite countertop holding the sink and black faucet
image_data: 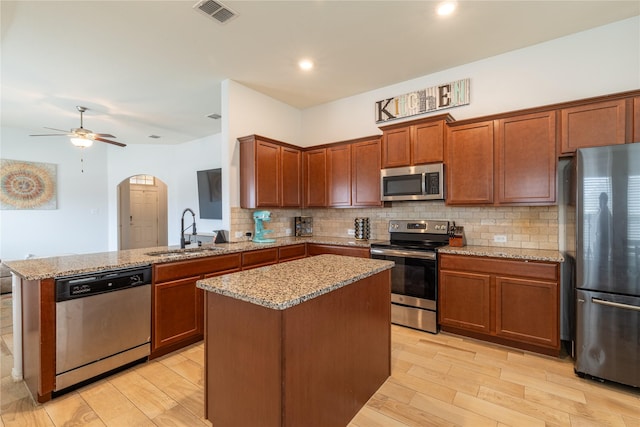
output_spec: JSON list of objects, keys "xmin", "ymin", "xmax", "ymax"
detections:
[{"xmin": 2, "ymin": 237, "xmax": 371, "ymax": 280}]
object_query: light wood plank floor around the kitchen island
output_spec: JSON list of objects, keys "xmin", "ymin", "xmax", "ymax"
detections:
[{"xmin": 0, "ymin": 296, "xmax": 640, "ymax": 427}]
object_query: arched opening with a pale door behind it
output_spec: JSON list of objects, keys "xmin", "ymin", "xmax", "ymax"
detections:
[{"xmin": 118, "ymin": 175, "xmax": 168, "ymax": 250}]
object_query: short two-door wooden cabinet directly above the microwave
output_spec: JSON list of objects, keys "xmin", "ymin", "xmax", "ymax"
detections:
[{"xmin": 380, "ymin": 114, "xmax": 453, "ymax": 168}]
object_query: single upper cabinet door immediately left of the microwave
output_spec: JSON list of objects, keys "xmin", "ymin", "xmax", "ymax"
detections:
[{"xmin": 351, "ymin": 139, "xmax": 382, "ymax": 206}]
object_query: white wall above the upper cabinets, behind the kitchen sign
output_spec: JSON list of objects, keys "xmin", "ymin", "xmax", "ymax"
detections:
[{"xmin": 301, "ymin": 17, "xmax": 640, "ymax": 146}]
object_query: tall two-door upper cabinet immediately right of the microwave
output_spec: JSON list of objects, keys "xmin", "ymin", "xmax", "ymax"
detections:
[{"xmin": 445, "ymin": 111, "xmax": 557, "ymax": 205}]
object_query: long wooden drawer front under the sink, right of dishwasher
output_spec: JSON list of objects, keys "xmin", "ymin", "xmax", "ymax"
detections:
[{"xmin": 153, "ymin": 253, "xmax": 240, "ymax": 283}]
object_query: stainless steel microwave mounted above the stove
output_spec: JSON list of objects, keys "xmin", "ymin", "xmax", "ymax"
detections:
[{"xmin": 380, "ymin": 163, "xmax": 444, "ymax": 201}]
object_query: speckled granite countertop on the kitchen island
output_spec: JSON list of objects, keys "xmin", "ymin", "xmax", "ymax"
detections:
[{"xmin": 196, "ymin": 255, "xmax": 394, "ymax": 310}]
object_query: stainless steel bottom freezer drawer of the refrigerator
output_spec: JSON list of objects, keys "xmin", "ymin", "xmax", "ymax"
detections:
[{"xmin": 575, "ymin": 289, "xmax": 640, "ymax": 387}]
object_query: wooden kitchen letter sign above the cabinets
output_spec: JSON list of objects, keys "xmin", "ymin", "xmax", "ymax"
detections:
[{"xmin": 376, "ymin": 79, "xmax": 470, "ymax": 123}]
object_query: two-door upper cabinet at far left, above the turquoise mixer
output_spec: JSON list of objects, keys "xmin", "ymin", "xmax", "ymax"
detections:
[{"xmin": 238, "ymin": 135, "xmax": 302, "ymax": 209}]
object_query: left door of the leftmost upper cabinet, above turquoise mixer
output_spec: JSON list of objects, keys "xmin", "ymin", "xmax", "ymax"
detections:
[{"xmin": 255, "ymin": 140, "xmax": 280, "ymax": 207}]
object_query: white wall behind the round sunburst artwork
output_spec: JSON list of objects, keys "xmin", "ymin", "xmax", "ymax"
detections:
[{"xmin": 0, "ymin": 128, "xmax": 109, "ymax": 260}]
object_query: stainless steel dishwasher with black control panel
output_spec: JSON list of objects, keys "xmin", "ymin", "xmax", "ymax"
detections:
[{"xmin": 54, "ymin": 266, "xmax": 151, "ymax": 391}]
